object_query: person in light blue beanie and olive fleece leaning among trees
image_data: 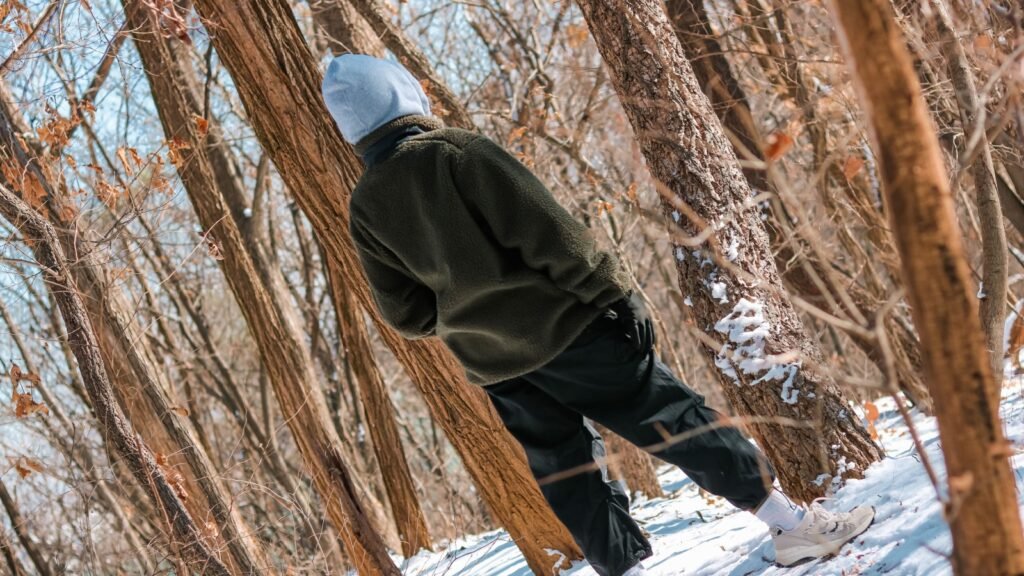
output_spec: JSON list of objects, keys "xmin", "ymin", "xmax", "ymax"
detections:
[{"xmin": 323, "ymin": 54, "xmax": 874, "ymax": 576}]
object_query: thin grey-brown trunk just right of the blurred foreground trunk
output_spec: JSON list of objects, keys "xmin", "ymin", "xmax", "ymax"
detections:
[{"xmin": 931, "ymin": 0, "xmax": 1008, "ymax": 381}]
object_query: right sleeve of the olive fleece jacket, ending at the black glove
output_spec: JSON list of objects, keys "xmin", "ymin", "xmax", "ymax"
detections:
[{"xmin": 456, "ymin": 136, "xmax": 628, "ymax": 307}]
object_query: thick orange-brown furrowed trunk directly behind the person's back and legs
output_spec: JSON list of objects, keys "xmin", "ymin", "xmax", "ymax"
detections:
[{"xmin": 187, "ymin": 0, "xmax": 581, "ymax": 574}]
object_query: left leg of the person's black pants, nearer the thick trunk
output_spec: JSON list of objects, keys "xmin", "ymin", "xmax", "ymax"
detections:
[{"xmin": 484, "ymin": 378, "xmax": 651, "ymax": 576}]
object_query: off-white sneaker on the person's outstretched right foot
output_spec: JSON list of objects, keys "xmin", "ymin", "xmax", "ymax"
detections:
[{"xmin": 771, "ymin": 498, "xmax": 874, "ymax": 566}]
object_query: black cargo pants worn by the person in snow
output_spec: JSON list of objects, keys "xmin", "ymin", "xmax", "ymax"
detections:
[{"xmin": 485, "ymin": 315, "xmax": 773, "ymax": 576}]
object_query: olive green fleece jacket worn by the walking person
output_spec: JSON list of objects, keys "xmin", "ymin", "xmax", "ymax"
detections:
[{"xmin": 350, "ymin": 116, "xmax": 628, "ymax": 385}]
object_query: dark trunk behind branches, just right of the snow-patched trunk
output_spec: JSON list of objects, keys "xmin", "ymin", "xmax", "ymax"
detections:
[{"xmin": 668, "ymin": 0, "xmax": 932, "ymax": 414}]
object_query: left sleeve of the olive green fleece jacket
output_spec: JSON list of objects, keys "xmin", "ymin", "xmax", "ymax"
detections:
[{"xmin": 349, "ymin": 218, "xmax": 437, "ymax": 339}]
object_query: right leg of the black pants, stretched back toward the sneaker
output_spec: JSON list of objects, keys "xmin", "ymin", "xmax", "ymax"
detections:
[{"xmin": 525, "ymin": 318, "xmax": 773, "ymax": 510}]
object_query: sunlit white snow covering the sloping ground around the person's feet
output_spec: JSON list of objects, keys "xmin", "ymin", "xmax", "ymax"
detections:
[{"xmin": 402, "ymin": 379, "xmax": 1024, "ymax": 576}]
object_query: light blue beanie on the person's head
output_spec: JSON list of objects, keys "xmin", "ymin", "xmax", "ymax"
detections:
[{"xmin": 323, "ymin": 54, "xmax": 430, "ymax": 146}]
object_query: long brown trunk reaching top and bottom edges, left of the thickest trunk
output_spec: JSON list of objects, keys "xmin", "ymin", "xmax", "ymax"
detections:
[{"xmin": 125, "ymin": 2, "xmax": 399, "ymax": 576}]
